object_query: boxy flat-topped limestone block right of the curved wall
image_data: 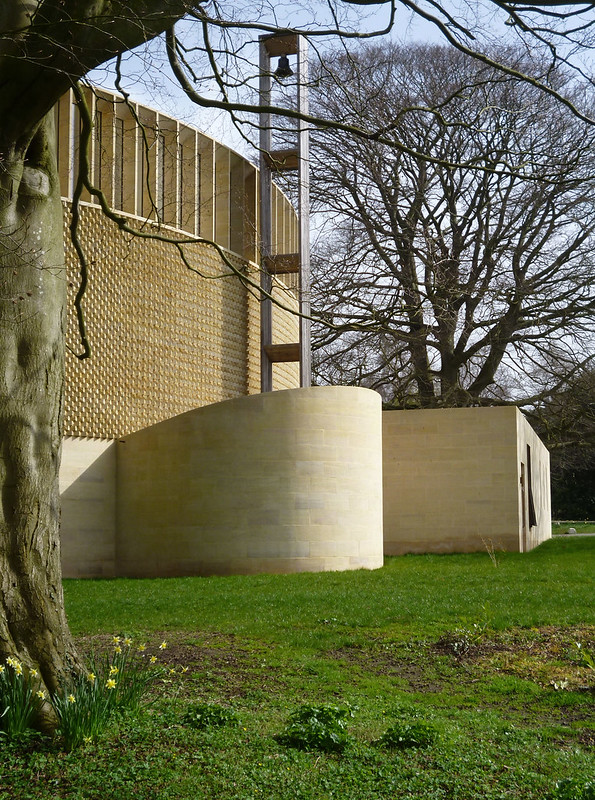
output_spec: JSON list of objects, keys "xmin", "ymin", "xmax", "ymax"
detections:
[{"xmin": 383, "ymin": 406, "xmax": 551, "ymax": 555}]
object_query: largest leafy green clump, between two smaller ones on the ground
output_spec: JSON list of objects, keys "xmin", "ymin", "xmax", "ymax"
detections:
[{"xmin": 277, "ymin": 704, "xmax": 353, "ymax": 753}]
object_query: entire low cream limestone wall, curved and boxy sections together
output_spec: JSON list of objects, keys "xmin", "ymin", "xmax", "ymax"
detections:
[{"xmin": 60, "ymin": 400, "xmax": 551, "ymax": 577}]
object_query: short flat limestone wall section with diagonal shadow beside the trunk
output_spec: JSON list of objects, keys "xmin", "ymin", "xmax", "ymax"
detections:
[{"xmin": 60, "ymin": 438, "xmax": 116, "ymax": 578}]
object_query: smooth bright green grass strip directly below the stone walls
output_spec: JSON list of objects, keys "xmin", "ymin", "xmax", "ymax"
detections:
[{"xmin": 65, "ymin": 538, "xmax": 595, "ymax": 648}]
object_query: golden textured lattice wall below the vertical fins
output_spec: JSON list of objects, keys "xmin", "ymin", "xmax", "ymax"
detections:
[{"xmin": 64, "ymin": 200, "xmax": 297, "ymax": 438}]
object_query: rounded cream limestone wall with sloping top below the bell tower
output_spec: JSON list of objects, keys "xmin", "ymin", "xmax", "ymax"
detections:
[{"xmin": 115, "ymin": 386, "xmax": 383, "ymax": 577}]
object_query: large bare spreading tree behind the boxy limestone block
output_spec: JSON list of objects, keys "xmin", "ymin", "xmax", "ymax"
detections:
[{"xmin": 313, "ymin": 45, "xmax": 595, "ymax": 407}]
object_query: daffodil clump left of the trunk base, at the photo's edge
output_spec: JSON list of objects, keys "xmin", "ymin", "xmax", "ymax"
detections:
[{"xmin": 0, "ymin": 657, "xmax": 45, "ymax": 738}]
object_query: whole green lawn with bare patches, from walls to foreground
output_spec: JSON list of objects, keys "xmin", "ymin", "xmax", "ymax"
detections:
[{"xmin": 0, "ymin": 538, "xmax": 595, "ymax": 800}]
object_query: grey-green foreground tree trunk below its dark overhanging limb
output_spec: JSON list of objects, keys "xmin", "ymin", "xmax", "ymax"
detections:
[{"xmin": 0, "ymin": 113, "xmax": 76, "ymax": 727}]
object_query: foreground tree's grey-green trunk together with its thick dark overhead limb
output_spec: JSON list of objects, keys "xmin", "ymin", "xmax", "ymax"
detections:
[{"xmin": 0, "ymin": 0, "xmax": 192, "ymax": 728}]
